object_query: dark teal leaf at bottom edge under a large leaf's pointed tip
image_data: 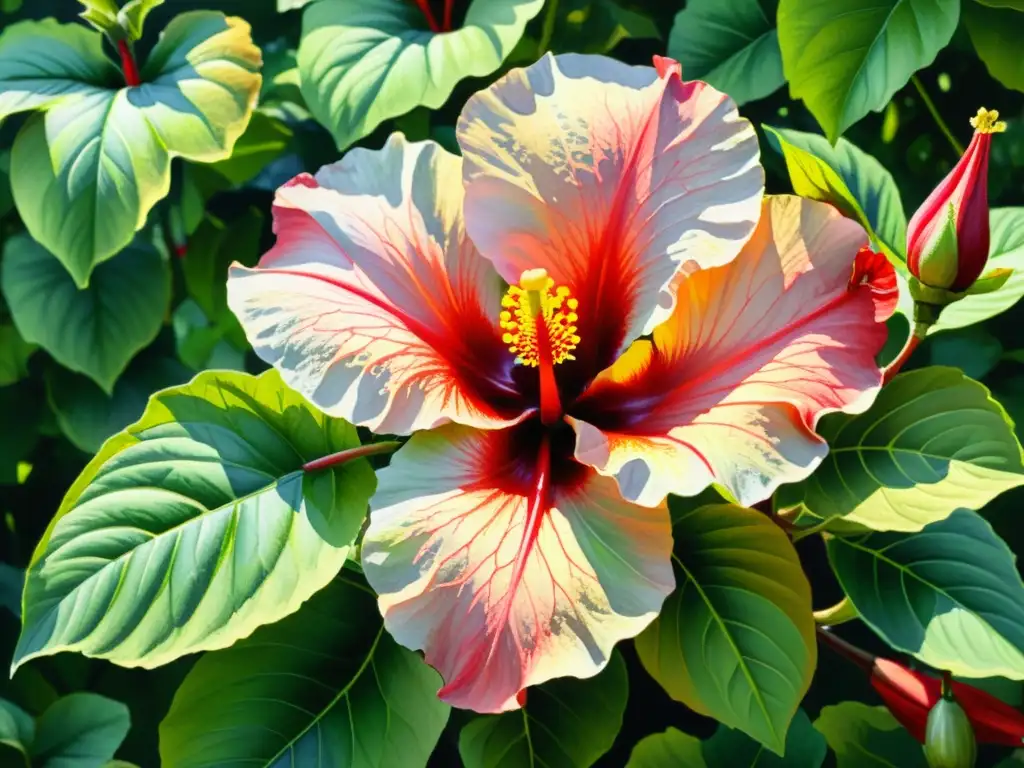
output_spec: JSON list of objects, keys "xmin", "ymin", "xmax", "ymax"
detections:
[{"xmin": 702, "ymin": 710, "xmax": 828, "ymax": 768}]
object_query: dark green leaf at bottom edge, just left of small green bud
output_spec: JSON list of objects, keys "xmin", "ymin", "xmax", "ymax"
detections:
[{"xmin": 814, "ymin": 701, "xmax": 927, "ymax": 768}]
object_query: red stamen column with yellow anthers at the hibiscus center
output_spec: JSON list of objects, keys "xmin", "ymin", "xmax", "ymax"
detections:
[{"xmin": 501, "ymin": 269, "xmax": 580, "ymax": 424}]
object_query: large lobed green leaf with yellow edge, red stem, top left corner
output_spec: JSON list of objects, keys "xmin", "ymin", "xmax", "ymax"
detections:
[{"xmin": 0, "ymin": 11, "xmax": 260, "ymax": 287}]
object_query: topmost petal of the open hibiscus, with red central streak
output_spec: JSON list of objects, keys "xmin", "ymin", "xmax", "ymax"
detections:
[{"xmin": 457, "ymin": 54, "xmax": 764, "ymax": 380}]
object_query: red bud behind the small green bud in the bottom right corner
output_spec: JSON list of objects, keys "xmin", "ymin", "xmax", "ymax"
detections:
[{"xmin": 818, "ymin": 632, "xmax": 1024, "ymax": 746}]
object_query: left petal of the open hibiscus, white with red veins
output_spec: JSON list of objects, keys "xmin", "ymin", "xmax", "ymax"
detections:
[{"xmin": 227, "ymin": 134, "xmax": 524, "ymax": 434}]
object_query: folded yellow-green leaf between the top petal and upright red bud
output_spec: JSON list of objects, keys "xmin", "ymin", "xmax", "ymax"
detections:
[{"xmin": 764, "ymin": 125, "xmax": 906, "ymax": 263}]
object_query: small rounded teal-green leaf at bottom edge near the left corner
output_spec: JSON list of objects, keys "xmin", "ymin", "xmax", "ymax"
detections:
[{"xmin": 32, "ymin": 693, "xmax": 131, "ymax": 768}]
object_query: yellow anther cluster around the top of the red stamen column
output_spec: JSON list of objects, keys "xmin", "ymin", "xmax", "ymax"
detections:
[{"xmin": 499, "ymin": 269, "xmax": 580, "ymax": 367}]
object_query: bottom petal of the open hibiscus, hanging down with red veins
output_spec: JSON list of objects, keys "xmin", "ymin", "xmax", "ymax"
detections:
[{"xmin": 361, "ymin": 425, "xmax": 674, "ymax": 713}]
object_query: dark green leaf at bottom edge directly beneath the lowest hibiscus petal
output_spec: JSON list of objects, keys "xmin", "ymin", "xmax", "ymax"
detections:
[{"xmin": 459, "ymin": 652, "xmax": 629, "ymax": 768}]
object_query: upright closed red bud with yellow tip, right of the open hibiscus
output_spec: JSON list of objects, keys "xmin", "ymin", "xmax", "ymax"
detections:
[{"xmin": 906, "ymin": 108, "xmax": 1007, "ymax": 292}]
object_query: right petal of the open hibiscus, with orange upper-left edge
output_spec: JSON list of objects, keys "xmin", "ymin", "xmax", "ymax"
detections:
[{"xmin": 569, "ymin": 196, "xmax": 897, "ymax": 512}]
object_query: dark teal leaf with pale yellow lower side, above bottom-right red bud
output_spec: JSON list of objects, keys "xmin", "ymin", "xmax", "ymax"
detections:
[{"xmin": 827, "ymin": 509, "xmax": 1024, "ymax": 680}]
